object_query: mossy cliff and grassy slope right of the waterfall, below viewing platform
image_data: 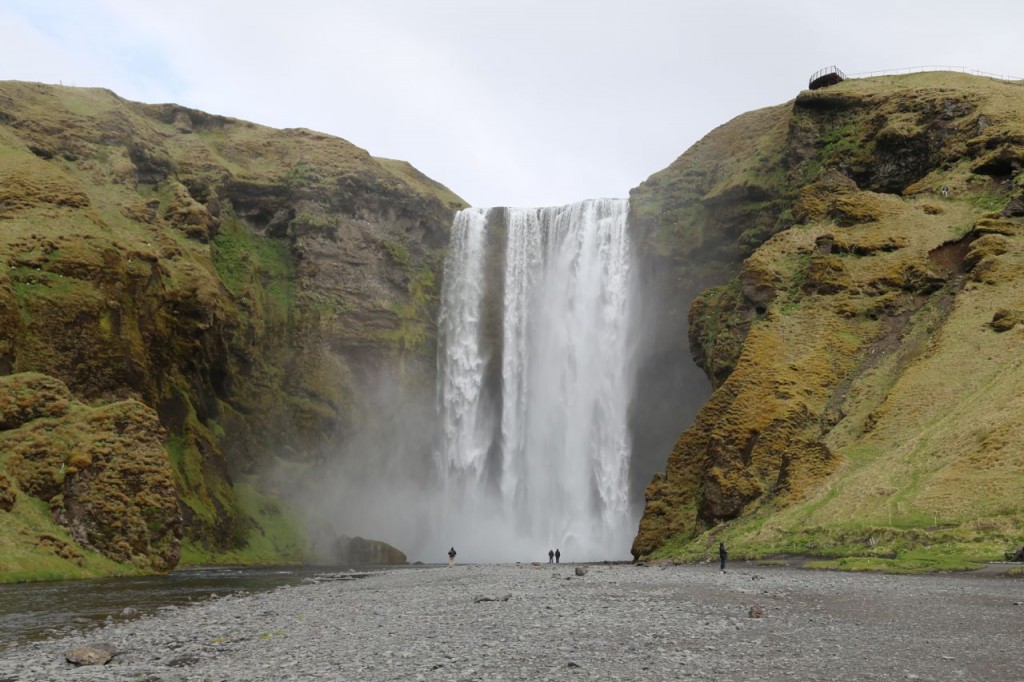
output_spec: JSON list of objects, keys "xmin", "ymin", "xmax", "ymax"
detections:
[{"xmin": 633, "ymin": 74, "xmax": 1024, "ymax": 565}]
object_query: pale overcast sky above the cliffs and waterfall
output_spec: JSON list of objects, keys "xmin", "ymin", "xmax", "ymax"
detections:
[{"xmin": 6, "ymin": 0, "xmax": 1024, "ymax": 206}]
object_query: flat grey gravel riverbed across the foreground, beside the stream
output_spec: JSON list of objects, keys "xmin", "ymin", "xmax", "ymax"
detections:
[{"xmin": 0, "ymin": 564, "xmax": 1024, "ymax": 682}]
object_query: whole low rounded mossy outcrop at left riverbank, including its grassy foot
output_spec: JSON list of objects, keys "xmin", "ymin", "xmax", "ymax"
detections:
[{"xmin": 0, "ymin": 372, "xmax": 182, "ymax": 580}]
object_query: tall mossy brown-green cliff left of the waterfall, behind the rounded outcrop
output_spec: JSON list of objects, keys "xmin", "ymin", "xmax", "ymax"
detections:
[{"xmin": 0, "ymin": 82, "xmax": 463, "ymax": 570}]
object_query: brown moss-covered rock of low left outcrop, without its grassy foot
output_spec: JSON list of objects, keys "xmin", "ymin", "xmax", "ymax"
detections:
[{"xmin": 0, "ymin": 374, "xmax": 182, "ymax": 571}]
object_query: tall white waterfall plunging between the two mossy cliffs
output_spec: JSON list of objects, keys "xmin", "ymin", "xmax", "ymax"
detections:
[{"xmin": 437, "ymin": 200, "xmax": 637, "ymax": 561}]
